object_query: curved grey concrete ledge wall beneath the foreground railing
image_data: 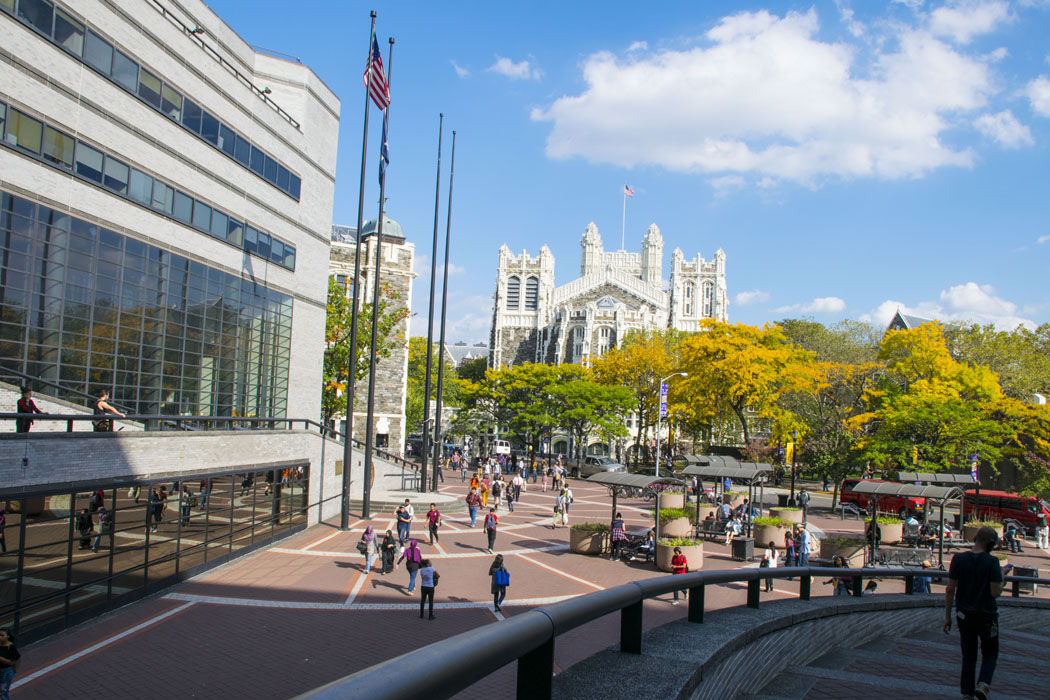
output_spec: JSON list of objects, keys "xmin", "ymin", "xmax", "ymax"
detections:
[{"xmin": 553, "ymin": 595, "xmax": 1050, "ymax": 700}]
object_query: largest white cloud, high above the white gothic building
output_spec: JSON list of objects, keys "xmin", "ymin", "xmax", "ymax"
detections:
[{"xmin": 532, "ymin": 9, "xmax": 995, "ymax": 184}]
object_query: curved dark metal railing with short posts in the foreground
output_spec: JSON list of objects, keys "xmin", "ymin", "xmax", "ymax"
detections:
[{"xmin": 298, "ymin": 567, "xmax": 1050, "ymax": 700}]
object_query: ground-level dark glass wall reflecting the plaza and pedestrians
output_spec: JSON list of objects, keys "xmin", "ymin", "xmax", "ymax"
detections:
[{"xmin": 0, "ymin": 466, "xmax": 310, "ymax": 643}]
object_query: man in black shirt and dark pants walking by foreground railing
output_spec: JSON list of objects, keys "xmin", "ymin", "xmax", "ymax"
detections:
[{"xmin": 944, "ymin": 527, "xmax": 1003, "ymax": 700}]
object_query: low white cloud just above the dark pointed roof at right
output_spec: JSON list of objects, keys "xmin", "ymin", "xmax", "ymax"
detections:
[{"xmin": 860, "ymin": 282, "xmax": 1035, "ymax": 331}]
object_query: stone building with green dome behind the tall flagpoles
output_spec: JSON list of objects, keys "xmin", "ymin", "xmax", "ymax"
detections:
[{"xmin": 329, "ymin": 216, "xmax": 416, "ymax": 452}]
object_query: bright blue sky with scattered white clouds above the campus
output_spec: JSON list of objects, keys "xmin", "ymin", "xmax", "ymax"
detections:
[{"xmin": 211, "ymin": 0, "xmax": 1050, "ymax": 342}]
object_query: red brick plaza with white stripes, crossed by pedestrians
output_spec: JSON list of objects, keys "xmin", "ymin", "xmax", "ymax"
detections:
[{"xmin": 14, "ymin": 476, "xmax": 1047, "ymax": 700}]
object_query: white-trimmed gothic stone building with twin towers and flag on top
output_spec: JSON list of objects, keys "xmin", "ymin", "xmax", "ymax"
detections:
[{"xmin": 489, "ymin": 222, "xmax": 729, "ymax": 367}]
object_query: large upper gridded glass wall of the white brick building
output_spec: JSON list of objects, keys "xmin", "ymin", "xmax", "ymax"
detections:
[{"xmin": 0, "ymin": 188, "xmax": 292, "ymax": 417}]
